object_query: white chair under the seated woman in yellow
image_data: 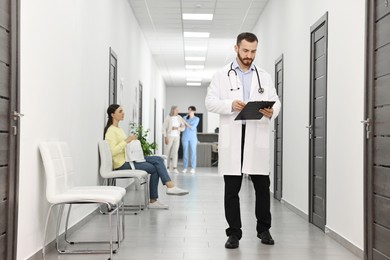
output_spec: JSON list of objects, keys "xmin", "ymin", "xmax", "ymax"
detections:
[{"xmin": 98, "ymin": 140, "xmax": 149, "ymax": 210}]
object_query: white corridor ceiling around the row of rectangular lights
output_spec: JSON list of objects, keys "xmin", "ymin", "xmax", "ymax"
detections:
[{"xmin": 128, "ymin": 0, "xmax": 268, "ymax": 87}]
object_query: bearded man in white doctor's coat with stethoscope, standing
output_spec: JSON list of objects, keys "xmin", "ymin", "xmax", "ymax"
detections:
[{"xmin": 205, "ymin": 32, "xmax": 281, "ymax": 249}]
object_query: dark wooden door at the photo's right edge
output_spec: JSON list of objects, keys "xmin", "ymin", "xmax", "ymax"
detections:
[{"xmin": 363, "ymin": 0, "xmax": 390, "ymax": 260}]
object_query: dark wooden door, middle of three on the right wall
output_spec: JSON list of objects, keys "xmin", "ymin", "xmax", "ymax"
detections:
[{"xmin": 309, "ymin": 13, "xmax": 328, "ymax": 230}]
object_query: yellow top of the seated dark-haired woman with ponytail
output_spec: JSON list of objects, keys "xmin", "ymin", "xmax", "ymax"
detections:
[{"xmin": 104, "ymin": 125, "xmax": 127, "ymax": 169}]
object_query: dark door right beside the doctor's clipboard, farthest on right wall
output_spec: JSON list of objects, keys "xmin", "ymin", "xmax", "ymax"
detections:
[{"xmin": 274, "ymin": 54, "xmax": 283, "ymax": 200}]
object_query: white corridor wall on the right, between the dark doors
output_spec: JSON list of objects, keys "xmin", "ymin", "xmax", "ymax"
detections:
[{"xmin": 254, "ymin": 0, "xmax": 365, "ymax": 249}]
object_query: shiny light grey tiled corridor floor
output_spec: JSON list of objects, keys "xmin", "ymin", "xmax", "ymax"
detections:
[{"xmin": 46, "ymin": 167, "xmax": 359, "ymax": 260}]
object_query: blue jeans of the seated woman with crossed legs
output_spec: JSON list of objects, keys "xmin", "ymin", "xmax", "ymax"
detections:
[{"xmin": 115, "ymin": 156, "xmax": 171, "ymax": 199}]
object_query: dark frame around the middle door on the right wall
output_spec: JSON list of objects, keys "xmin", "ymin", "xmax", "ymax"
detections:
[{"xmin": 308, "ymin": 12, "xmax": 328, "ymax": 231}]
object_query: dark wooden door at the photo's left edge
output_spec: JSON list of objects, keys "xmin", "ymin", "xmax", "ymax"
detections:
[{"xmin": 0, "ymin": 0, "xmax": 19, "ymax": 259}]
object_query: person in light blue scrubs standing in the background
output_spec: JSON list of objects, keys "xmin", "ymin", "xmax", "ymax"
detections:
[{"xmin": 181, "ymin": 106, "xmax": 199, "ymax": 173}]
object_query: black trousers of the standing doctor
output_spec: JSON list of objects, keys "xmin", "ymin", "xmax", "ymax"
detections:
[{"xmin": 224, "ymin": 125, "xmax": 271, "ymax": 239}]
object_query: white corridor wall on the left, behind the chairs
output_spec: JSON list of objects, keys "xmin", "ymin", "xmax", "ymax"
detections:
[{"xmin": 17, "ymin": 0, "xmax": 165, "ymax": 259}]
